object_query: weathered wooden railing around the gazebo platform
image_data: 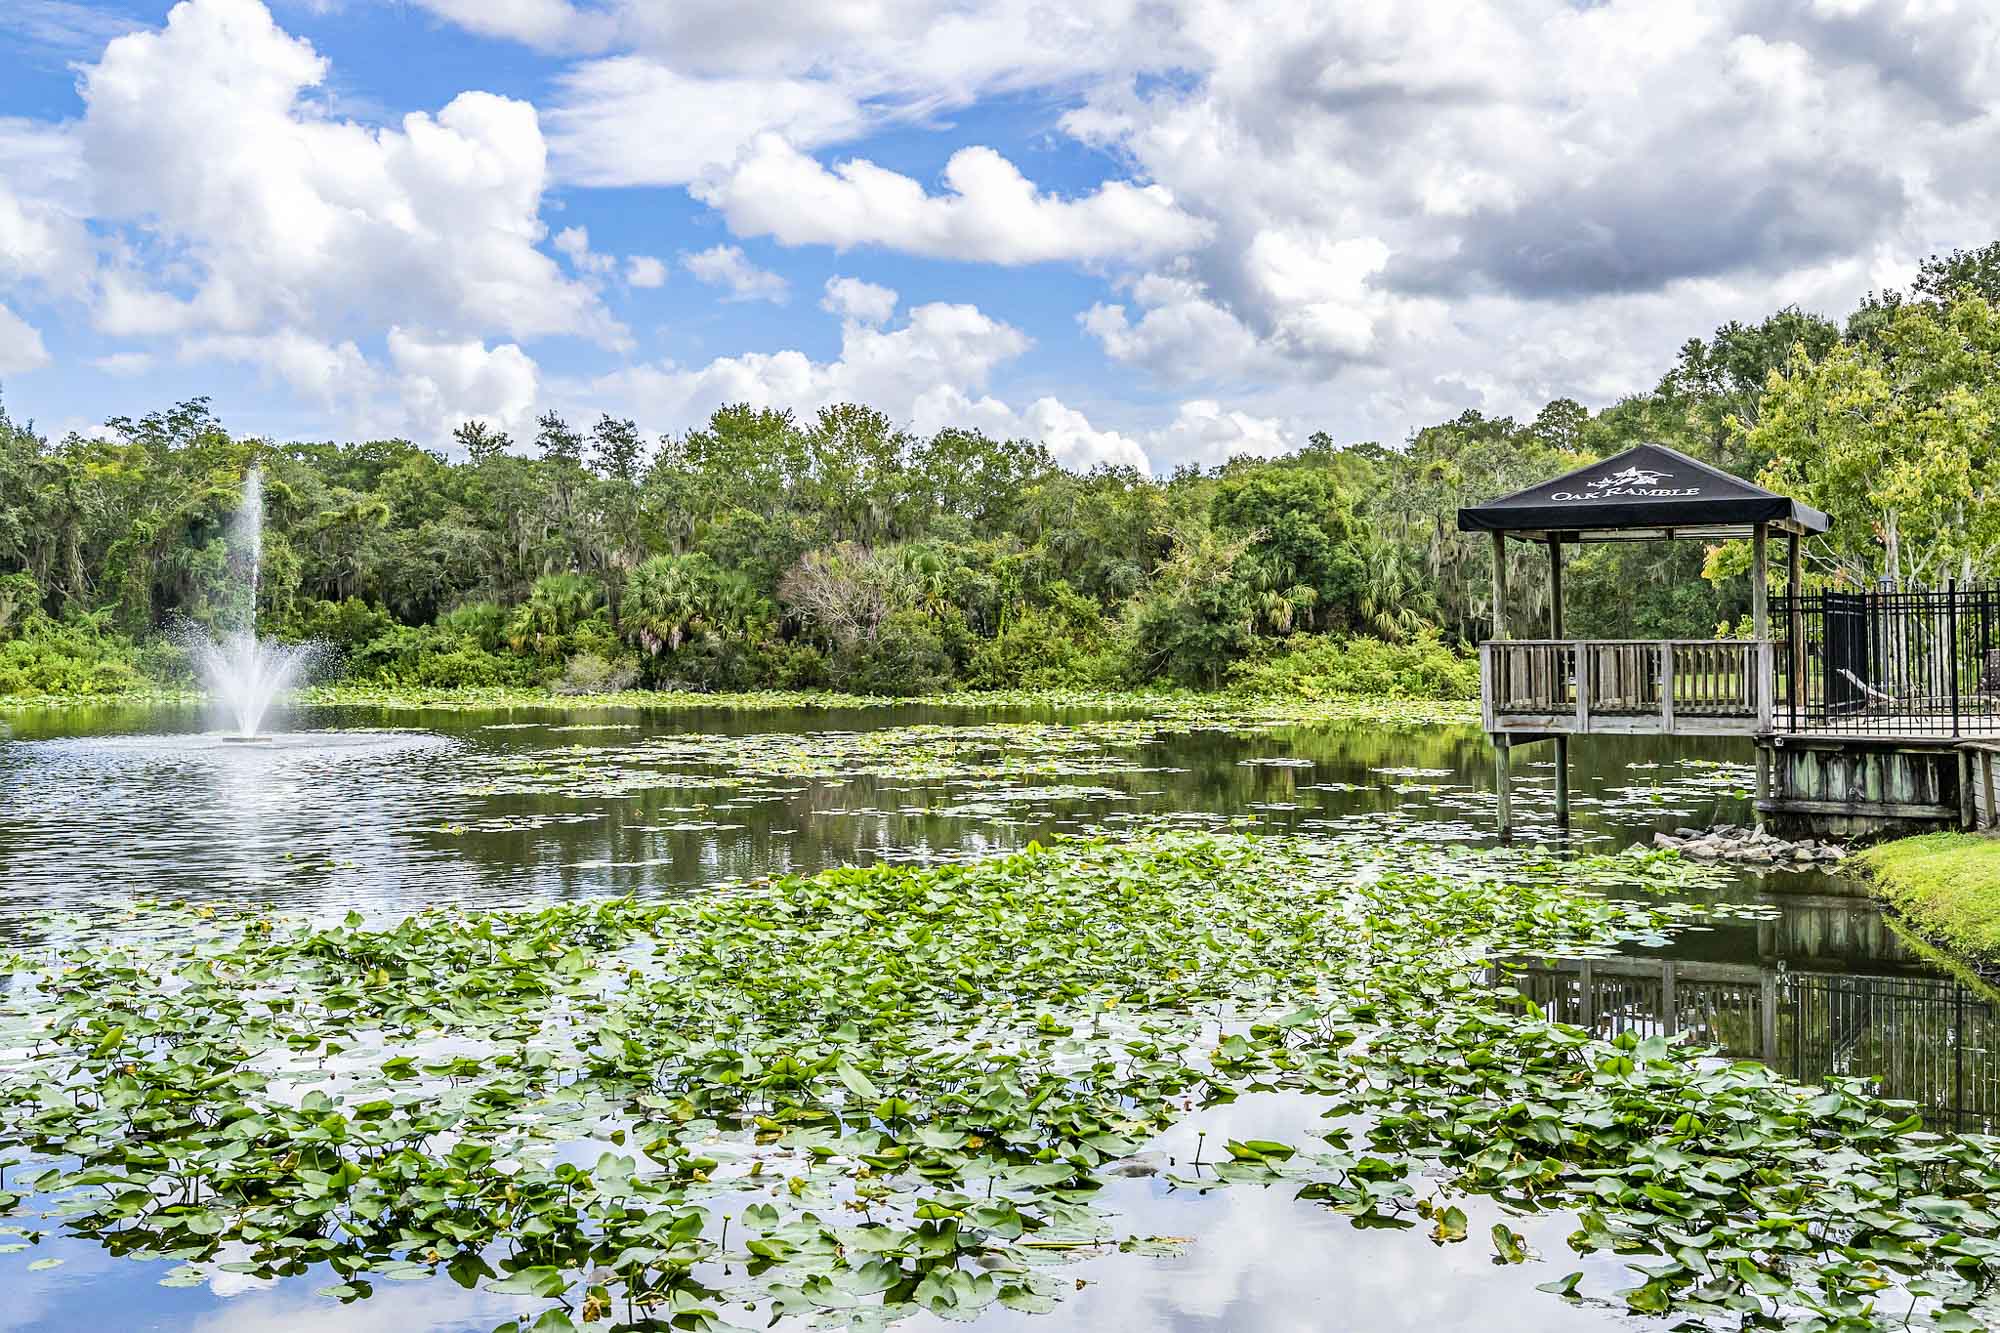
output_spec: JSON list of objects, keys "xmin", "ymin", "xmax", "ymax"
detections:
[{"xmin": 1480, "ymin": 638, "xmax": 1774, "ymax": 735}]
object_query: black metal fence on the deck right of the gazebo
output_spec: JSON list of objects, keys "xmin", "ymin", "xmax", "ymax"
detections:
[{"xmin": 1772, "ymin": 582, "xmax": 2000, "ymax": 737}]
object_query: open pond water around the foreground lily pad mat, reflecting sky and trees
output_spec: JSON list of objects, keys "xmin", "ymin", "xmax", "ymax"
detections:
[{"xmin": 0, "ymin": 707, "xmax": 2000, "ymax": 1333}]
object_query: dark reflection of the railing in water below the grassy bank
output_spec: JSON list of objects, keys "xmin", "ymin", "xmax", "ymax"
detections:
[{"xmin": 1504, "ymin": 957, "xmax": 2000, "ymax": 1131}]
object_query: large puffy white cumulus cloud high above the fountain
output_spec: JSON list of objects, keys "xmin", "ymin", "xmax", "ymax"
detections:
[{"xmin": 76, "ymin": 0, "xmax": 620, "ymax": 342}]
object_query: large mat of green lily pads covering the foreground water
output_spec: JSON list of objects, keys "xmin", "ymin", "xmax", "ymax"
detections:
[{"xmin": 0, "ymin": 833, "xmax": 1968, "ymax": 1329}]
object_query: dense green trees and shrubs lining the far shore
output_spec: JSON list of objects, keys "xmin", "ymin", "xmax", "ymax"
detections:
[{"xmin": 11, "ymin": 246, "xmax": 2000, "ymax": 695}]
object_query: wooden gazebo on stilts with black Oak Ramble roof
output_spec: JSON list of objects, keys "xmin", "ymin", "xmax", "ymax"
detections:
[{"xmin": 1458, "ymin": 444, "xmax": 1828, "ymax": 831}]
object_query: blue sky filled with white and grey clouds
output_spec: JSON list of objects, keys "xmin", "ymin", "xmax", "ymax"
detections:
[{"xmin": 0, "ymin": 0, "xmax": 2000, "ymax": 470}]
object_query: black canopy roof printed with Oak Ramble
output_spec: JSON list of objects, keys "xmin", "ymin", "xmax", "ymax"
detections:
[{"xmin": 1458, "ymin": 444, "xmax": 1828, "ymax": 542}]
